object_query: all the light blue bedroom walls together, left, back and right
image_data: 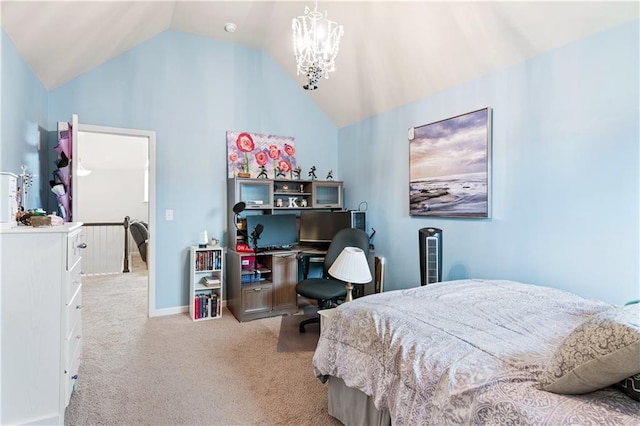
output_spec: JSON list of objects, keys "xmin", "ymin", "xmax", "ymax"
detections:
[{"xmin": 0, "ymin": 21, "xmax": 640, "ymax": 309}]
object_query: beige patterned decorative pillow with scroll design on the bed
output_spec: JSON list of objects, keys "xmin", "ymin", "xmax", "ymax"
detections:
[{"xmin": 540, "ymin": 304, "xmax": 640, "ymax": 394}]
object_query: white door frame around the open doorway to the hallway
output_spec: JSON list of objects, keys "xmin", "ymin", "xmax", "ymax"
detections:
[{"xmin": 71, "ymin": 119, "xmax": 158, "ymax": 317}]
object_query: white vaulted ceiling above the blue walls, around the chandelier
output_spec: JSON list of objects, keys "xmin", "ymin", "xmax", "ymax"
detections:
[{"xmin": 1, "ymin": 0, "xmax": 640, "ymax": 127}]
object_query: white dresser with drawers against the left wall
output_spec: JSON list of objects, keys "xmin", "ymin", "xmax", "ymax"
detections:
[{"xmin": 0, "ymin": 223, "xmax": 84, "ymax": 425}]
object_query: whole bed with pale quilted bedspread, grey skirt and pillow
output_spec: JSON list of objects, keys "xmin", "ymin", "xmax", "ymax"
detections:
[{"xmin": 313, "ymin": 280, "xmax": 640, "ymax": 425}]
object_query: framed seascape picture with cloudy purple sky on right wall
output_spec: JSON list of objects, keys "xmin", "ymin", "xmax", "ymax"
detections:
[{"xmin": 409, "ymin": 108, "xmax": 491, "ymax": 218}]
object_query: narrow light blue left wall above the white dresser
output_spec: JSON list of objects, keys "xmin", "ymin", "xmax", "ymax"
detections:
[{"xmin": 0, "ymin": 30, "xmax": 51, "ymax": 209}]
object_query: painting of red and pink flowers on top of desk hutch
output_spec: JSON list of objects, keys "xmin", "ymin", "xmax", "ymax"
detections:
[{"xmin": 227, "ymin": 131, "xmax": 296, "ymax": 179}]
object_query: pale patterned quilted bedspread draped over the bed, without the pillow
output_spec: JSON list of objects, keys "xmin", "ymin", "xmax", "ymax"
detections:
[{"xmin": 313, "ymin": 280, "xmax": 640, "ymax": 426}]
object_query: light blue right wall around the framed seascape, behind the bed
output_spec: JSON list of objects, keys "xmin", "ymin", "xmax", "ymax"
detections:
[{"xmin": 340, "ymin": 20, "xmax": 640, "ymax": 303}]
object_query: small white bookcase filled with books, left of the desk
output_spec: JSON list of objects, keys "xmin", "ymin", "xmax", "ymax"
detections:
[{"xmin": 189, "ymin": 246, "xmax": 224, "ymax": 321}]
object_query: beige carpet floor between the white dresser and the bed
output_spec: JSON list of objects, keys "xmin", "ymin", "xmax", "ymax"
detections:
[{"xmin": 65, "ymin": 255, "xmax": 340, "ymax": 425}]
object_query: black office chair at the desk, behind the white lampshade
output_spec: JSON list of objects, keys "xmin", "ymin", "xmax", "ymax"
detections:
[{"xmin": 296, "ymin": 228, "xmax": 369, "ymax": 333}]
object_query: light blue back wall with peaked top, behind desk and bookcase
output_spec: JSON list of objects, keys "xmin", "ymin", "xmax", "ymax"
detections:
[{"xmin": 49, "ymin": 31, "xmax": 338, "ymax": 309}]
